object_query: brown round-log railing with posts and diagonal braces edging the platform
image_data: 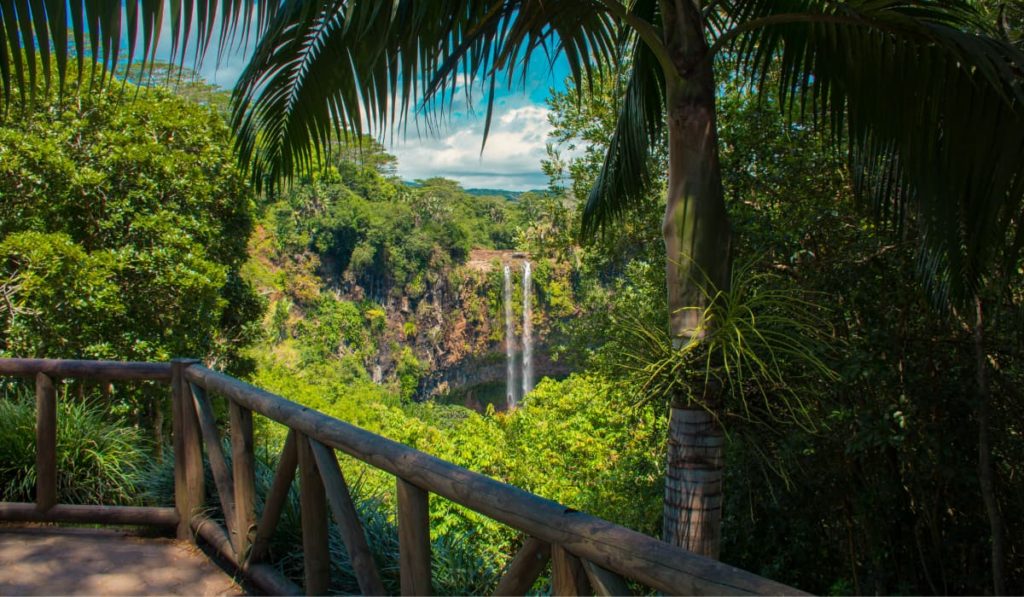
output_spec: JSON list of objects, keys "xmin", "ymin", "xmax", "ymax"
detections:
[{"xmin": 0, "ymin": 359, "xmax": 799, "ymax": 595}]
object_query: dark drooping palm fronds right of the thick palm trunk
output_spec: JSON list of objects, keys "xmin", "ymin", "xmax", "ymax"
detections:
[{"xmin": 715, "ymin": 0, "xmax": 1024, "ymax": 304}]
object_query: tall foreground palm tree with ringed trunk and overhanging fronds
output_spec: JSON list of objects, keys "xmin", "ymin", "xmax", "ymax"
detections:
[{"xmin": 0, "ymin": 0, "xmax": 1024, "ymax": 585}]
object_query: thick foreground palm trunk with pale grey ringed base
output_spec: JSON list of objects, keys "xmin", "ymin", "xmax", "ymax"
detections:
[{"xmin": 662, "ymin": 0, "xmax": 731, "ymax": 558}]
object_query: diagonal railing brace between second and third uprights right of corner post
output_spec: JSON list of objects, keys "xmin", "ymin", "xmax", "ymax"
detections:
[{"xmin": 303, "ymin": 439, "xmax": 384, "ymax": 595}]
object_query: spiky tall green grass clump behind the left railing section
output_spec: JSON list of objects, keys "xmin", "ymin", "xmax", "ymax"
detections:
[{"xmin": 0, "ymin": 390, "xmax": 150, "ymax": 505}]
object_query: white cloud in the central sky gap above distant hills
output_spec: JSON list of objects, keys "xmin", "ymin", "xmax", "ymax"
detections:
[{"xmin": 391, "ymin": 96, "xmax": 551, "ymax": 190}]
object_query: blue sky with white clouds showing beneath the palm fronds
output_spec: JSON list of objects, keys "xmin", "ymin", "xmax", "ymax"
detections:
[{"xmin": 158, "ymin": 23, "xmax": 568, "ymax": 190}]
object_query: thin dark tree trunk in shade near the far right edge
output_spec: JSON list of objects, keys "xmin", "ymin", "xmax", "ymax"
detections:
[{"xmin": 974, "ymin": 296, "xmax": 1007, "ymax": 595}]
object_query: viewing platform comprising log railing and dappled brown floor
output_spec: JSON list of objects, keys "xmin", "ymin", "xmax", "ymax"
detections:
[{"xmin": 0, "ymin": 359, "xmax": 800, "ymax": 595}]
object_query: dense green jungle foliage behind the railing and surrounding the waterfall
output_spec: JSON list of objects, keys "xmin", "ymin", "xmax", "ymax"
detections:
[{"xmin": 0, "ymin": 57, "xmax": 1024, "ymax": 594}]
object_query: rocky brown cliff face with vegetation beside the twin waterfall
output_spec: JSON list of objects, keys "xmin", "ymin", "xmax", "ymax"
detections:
[{"xmin": 246, "ymin": 209, "xmax": 574, "ymax": 407}]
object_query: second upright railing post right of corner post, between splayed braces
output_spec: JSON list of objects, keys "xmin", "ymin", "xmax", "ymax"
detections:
[{"xmin": 295, "ymin": 434, "xmax": 329, "ymax": 595}]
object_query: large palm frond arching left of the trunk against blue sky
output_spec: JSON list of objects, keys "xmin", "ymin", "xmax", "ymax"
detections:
[{"xmin": 234, "ymin": 0, "xmax": 614, "ymax": 191}]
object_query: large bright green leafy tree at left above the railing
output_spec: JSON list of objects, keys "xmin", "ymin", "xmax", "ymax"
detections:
[{"xmin": 0, "ymin": 69, "xmax": 263, "ymax": 367}]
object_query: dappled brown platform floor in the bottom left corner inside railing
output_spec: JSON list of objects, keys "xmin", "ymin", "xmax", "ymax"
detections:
[{"xmin": 0, "ymin": 525, "xmax": 244, "ymax": 595}]
